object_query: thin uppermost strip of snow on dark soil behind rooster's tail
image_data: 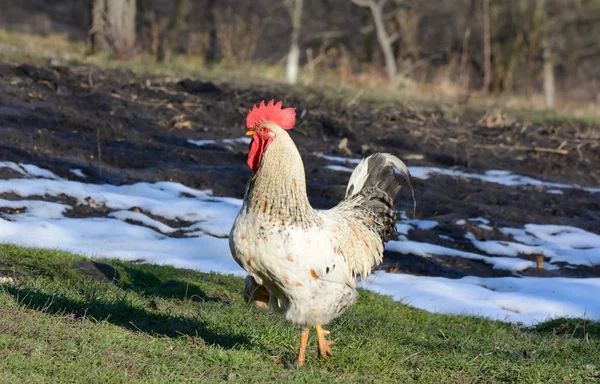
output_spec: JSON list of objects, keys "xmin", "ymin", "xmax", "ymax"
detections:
[{"xmin": 317, "ymin": 154, "xmax": 600, "ymax": 194}]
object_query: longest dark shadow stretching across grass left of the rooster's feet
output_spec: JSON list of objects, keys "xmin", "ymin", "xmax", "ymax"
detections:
[{"xmin": 6, "ymin": 287, "xmax": 252, "ymax": 349}]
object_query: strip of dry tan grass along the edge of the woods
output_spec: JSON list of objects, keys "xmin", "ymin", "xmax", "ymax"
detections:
[{"xmin": 0, "ymin": 25, "xmax": 600, "ymax": 124}]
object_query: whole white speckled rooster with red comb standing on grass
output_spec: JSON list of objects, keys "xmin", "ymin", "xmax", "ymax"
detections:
[{"xmin": 229, "ymin": 100, "xmax": 414, "ymax": 366}]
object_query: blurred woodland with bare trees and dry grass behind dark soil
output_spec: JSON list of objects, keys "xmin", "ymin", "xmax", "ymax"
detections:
[{"xmin": 0, "ymin": 0, "xmax": 600, "ymax": 116}]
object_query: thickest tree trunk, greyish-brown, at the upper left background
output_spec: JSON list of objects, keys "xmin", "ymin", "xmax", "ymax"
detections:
[{"xmin": 89, "ymin": 0, "xmax": 136, "ymax": 58}]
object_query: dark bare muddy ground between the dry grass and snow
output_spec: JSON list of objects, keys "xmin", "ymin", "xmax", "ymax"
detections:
[{"xmin": 0, "ymin": 63, "xmax": 600, "ymax": 277}]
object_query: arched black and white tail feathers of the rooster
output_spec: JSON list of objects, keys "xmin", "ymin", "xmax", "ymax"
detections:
[{"xmin": 346, "ymin": 153, "xmax": 417, "ymax": 241}]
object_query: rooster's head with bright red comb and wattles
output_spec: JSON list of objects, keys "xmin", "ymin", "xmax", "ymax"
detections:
[{"xmin": 246, "ymin": 100, "xmax": 296, "ymax": 172}]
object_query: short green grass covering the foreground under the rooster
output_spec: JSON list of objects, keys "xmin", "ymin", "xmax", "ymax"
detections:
[{"xmin": 0, "ymin": 245, "xmax": 600, "ymax": 383}]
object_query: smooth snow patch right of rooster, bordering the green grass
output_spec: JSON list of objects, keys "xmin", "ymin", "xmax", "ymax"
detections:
[{"xmin": 364, "ymin": 272, "xmax": 600, "ymax": 326}]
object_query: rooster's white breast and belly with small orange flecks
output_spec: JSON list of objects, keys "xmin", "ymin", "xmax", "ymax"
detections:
[{"xmin": 230, "ymin": 213, "xmax": 356, "ymax": 325}]
